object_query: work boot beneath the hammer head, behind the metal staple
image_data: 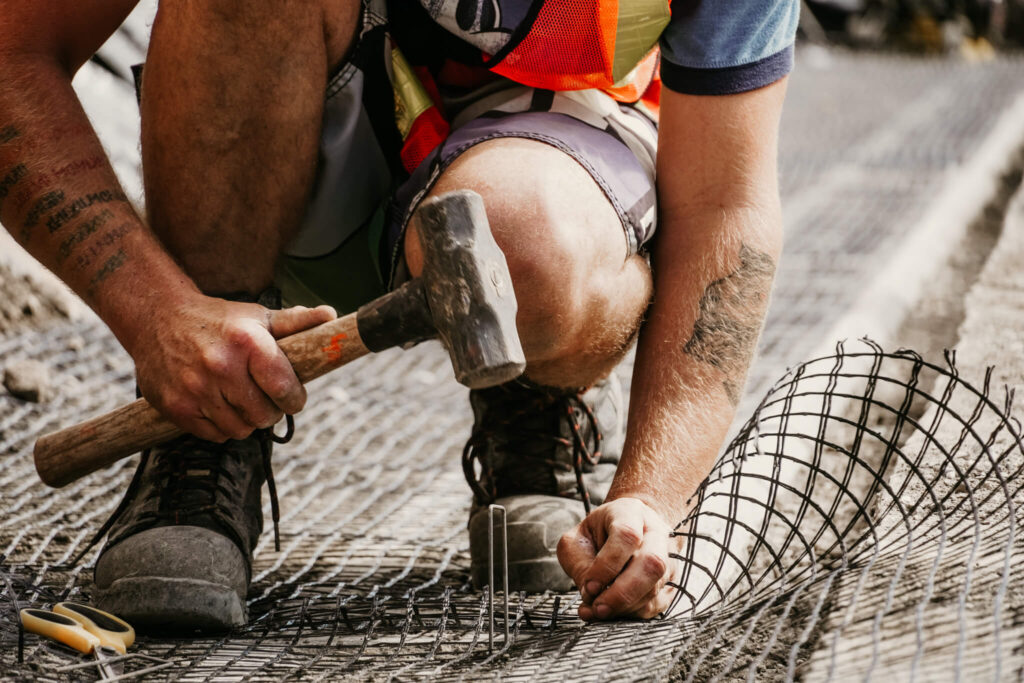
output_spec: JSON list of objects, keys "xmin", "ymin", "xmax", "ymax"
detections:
[{"xmin": 463, "ymin": 376, "xmax": 625, "ymax": 592}]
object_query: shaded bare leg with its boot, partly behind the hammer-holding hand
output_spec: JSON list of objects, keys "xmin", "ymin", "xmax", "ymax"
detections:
[{"xmin": 93, "ymin": 0, "xmax": 358, "ymax": 633}]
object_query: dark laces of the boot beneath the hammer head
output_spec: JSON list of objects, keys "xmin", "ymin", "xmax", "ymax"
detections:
[{"xmin": 462, "ymin": 387, "xmax": 603, "ymax": 515}]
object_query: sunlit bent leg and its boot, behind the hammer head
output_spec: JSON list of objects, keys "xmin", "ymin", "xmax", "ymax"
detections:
[{"xmin": 403, "ymin": 119, "xmax": 652, "ymax": 591}]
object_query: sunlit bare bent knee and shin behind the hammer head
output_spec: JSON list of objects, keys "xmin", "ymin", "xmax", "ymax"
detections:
[{"xmin": 404, "ymin": 138, "xmax": 651, "ymax": 387}]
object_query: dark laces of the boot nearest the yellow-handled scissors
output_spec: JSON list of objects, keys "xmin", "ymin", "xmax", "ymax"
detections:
[{"xmin": 70, "ymin": 415, "xmax": 295, "ymax": 566}]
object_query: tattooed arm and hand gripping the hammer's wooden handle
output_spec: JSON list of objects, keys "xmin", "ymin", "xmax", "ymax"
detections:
[{"xmin": 0, "ymin": 0, "xmax": 334, "ymax": 441}]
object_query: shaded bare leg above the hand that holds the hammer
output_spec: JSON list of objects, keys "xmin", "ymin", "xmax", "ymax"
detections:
[{"xmin": 142, "ymin": 0, "xmax": 359, "ymax": 293}]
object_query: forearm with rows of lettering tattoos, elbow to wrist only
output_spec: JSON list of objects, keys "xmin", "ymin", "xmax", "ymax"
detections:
[{"xmin": 0, "ymin": 54, "xmax": 196, "ymax": 343}]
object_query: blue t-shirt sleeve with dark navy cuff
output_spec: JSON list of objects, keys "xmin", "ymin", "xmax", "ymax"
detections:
[{"xmin": 662, "ymin": 0, "xmax": 800, "ymax": 95}]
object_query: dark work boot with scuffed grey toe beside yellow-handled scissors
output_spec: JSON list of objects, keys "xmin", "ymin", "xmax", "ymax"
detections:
[{"xmin": 93, "ymin": 422, "xmax": 291, "ymax": 633}]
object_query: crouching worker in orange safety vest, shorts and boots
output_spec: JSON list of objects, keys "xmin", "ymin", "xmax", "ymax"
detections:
[{"xmin": 0, "ymin": 0, "xmax": 799, "ymax": 631}]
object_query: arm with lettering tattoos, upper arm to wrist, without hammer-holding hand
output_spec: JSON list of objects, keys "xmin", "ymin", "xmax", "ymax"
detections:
[{"xmin": 0, "ymin": 0, "xmax": 195, "ymax": 327}]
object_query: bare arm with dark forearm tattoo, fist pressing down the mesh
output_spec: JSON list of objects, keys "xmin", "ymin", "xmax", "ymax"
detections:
[{"xmin": 559, "ymin": 80, "xmax": 785, "ymax": 618}]
